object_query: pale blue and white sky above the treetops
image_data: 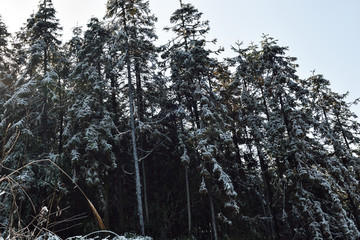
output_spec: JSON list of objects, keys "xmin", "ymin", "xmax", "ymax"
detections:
[{"xmin": 0, "ymin": 0, "xmax": 360, "ymax": 116}]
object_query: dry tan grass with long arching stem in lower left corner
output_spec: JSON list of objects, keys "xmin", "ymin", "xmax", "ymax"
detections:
[{"xmin": 0, "ymin": 125, "xmax": 106, "ymax": 240}]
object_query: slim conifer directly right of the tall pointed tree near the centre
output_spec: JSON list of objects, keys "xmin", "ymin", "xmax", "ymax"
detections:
[{"xmin": 223, "ymin": 41, "xmax": 279, "ymax": 239}]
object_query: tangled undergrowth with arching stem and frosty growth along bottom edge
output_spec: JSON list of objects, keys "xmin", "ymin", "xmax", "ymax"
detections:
[{"xmin": 0, "ymin": 125, "xmax": 151, "ymax": 240}]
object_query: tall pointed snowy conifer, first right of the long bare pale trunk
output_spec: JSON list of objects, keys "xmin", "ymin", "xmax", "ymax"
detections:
[{"xmin": 167, "ymin": 1, "xmax": 238, "ymax": 239}]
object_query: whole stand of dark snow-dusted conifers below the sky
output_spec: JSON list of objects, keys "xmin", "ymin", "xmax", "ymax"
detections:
[{"xmin": 0, "ymin": 0, "xmax": 360, "ymax": 240}]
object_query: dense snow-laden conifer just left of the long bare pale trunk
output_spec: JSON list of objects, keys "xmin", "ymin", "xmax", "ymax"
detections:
[{"xmin": 64, "ymin": 18, "xmax": 117, "ymax": 229}]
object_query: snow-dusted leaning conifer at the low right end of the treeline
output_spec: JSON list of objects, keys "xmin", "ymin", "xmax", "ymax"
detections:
[{"xmin": 306, "ymin": 75, "xmax": 359, "ymax": 234}]
